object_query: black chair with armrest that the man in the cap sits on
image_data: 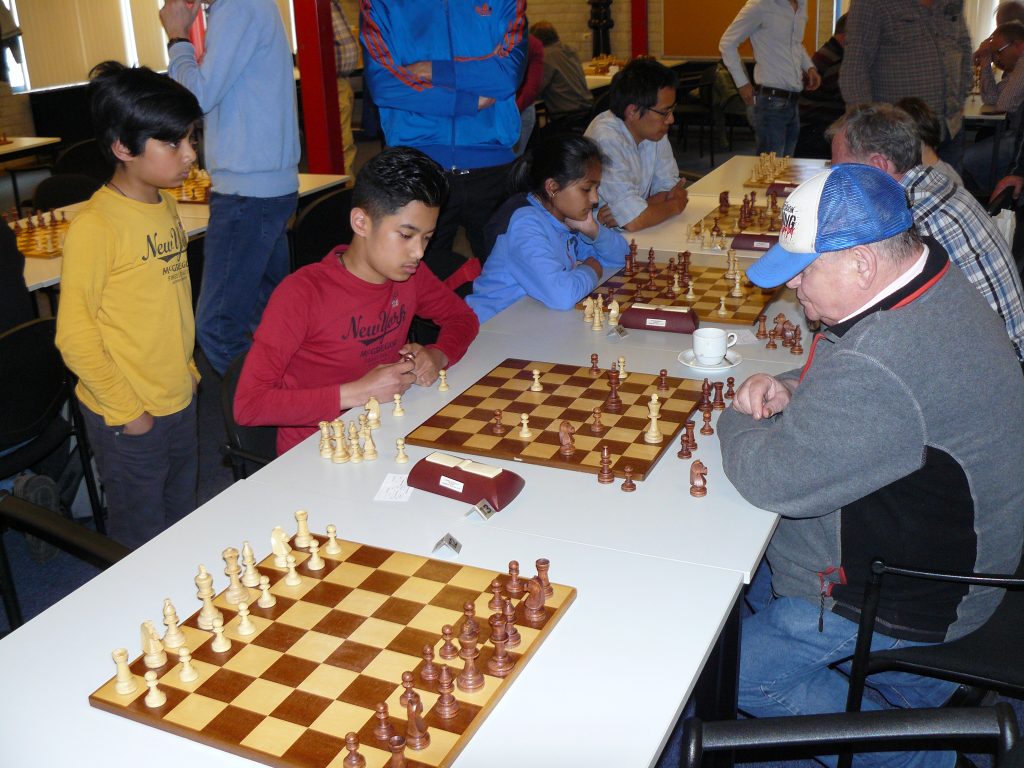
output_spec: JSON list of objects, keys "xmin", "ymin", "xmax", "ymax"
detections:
[{"xmin": 847, "ymin": 558, "xmax": 1024, "ymax": 712}]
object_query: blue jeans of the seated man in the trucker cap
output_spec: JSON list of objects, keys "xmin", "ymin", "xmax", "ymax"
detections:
[{"xmin": 739, "ymin": 566, "xmax": 956, "ymax": 768}]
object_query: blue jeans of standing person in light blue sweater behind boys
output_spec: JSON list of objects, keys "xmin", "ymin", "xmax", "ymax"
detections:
[{"xmin": 196, "ymin": 193, "xmax": 298, "ymax": 375}]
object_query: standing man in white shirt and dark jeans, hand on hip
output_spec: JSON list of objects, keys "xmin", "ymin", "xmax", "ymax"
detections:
[{"xmin": 718, "ymin": 0, "xmax": 821, "ymax": 156}]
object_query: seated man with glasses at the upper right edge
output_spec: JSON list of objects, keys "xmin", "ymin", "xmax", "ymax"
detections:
[{"xmin": 964, "ymin": 22, "xmax": 1024, "ymax": 193}]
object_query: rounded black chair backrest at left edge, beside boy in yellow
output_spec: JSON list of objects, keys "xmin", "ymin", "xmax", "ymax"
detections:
[{"xmin": 0, "ymin": 317, "xmax": 69, "ymax": 451}]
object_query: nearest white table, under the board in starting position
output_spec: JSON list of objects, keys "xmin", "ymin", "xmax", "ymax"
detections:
[{"xmin": 0, "ymin": 479, "xmax": 740, "ymax": 768}]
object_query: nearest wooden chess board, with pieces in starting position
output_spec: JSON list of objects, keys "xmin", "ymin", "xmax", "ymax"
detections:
[{"xmin": 89, "ymin": 536, "xmax": 575, "ymax": 768}]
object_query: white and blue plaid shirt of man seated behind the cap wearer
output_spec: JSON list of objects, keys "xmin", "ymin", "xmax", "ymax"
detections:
[{"xmin": 900, "ymin": 165, "xmax": 1024, "ymax": 360}]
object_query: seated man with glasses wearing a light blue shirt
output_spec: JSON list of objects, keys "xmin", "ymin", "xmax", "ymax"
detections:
[{"xmin": 585, "ymin": 58, "xmax": 686, "ymax": 232}]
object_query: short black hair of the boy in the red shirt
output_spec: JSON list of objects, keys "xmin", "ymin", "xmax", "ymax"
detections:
[{"xmin": 352, "ymin": 146, "xmax": 447, "ymax": 217}]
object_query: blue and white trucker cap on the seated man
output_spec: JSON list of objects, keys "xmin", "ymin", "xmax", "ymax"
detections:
[{"xmin": 746, "ymin": 163, "xmax": 913, "ymax": 288}]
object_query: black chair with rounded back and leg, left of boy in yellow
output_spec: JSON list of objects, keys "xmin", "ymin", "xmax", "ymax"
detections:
[{"xmin": 0, "ymin": 317, "xmax": 106, "ymax": 534}]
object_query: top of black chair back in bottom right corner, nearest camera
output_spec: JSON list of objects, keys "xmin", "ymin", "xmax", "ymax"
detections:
[{"xmin": 682, "ymin": 702, "xmax": 1020, "ymax": 768}]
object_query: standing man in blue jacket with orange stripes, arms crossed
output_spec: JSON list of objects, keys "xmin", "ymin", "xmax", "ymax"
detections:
[{"xmin": 360, "ymin": 0, "xmax": 526, "ymax": 278}]
